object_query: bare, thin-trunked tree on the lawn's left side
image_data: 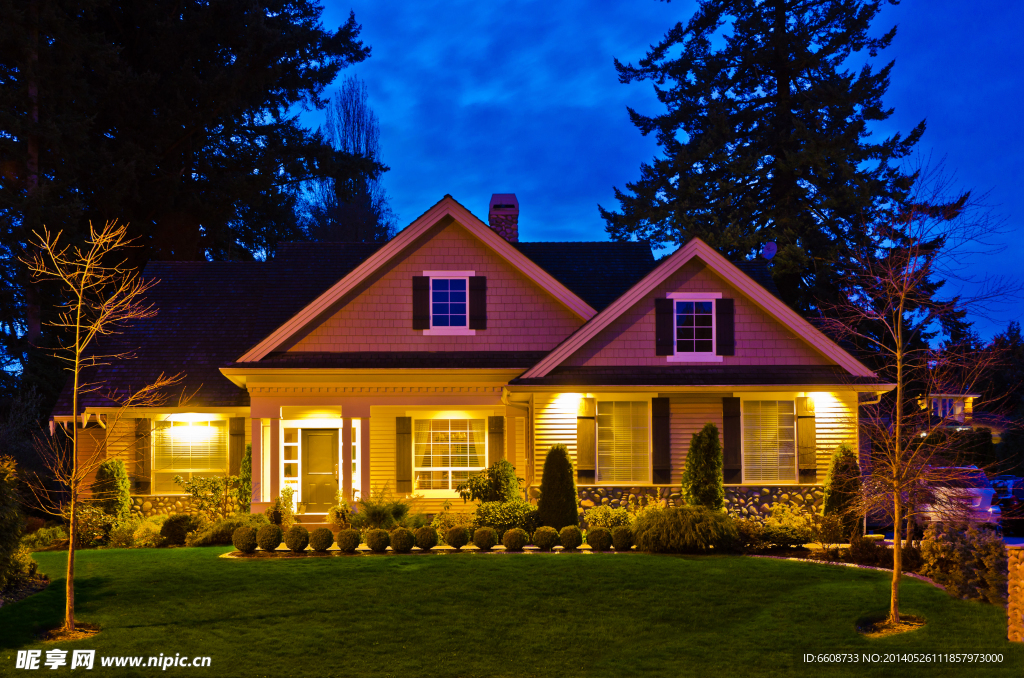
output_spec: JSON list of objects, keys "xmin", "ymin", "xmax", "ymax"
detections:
[{"xmin": 24, "ymin": 222, "xmax": 181, "ymax": 633}]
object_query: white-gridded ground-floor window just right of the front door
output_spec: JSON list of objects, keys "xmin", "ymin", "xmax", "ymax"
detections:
[{"xmin": 413, "ymin": 419, "xmax": 487, "ymax": 490}]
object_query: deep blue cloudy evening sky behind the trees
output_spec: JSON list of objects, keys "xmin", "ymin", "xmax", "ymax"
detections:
[{"xmin": 313, "ymin": 0, "xmax": 1024, "ymax": 337}]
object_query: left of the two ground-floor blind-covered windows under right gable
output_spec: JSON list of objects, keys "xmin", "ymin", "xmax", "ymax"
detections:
[{"xmin": 597, "ymin": 401, "xmax": 650, "ymax": 483}]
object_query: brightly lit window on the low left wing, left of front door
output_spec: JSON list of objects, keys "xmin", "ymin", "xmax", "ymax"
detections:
[{"xmin": 153, "ymin": 420, "xmax": 227, "ymax": 494}]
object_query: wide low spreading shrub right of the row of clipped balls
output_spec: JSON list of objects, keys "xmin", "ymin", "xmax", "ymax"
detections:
[{"xmin": 633, "ymin": 506, "xmax": 738, "ymax": 553}]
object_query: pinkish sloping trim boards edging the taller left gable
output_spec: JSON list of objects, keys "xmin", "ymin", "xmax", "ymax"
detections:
[{"xmin": 238, "ymin": 196, "xmax": 597, "ymax": 363}]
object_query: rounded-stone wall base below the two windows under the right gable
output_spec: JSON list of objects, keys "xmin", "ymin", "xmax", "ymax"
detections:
[{"xmin": 577, "ymin": 485, "xmax": 824, "ymax": 517}]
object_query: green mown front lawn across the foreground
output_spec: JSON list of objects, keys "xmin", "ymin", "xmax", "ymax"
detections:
[{"xmin": 0, "ymin": 548, "xmax": 1024, "ymax": 678}]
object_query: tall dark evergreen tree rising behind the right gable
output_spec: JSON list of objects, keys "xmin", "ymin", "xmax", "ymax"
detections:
[{"xmin": 600, "ymin": 0, "xmax": 925, "ymax": 312}]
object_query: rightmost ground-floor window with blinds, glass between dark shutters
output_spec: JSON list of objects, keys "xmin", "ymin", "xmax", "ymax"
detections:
[{"xmin": 743, "ymin": 400, "xmax": 797, "ymax": 482}]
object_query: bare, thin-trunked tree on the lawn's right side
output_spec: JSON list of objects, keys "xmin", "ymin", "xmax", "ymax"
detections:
[{"xmin": 822, "ymin": 163, "xmax": 1020, "ymax": 624}]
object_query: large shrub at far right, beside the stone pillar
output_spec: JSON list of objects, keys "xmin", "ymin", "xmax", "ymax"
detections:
[{"xmin": 921, "ymin": 522, "xmax": 1008, "ymax": 604}]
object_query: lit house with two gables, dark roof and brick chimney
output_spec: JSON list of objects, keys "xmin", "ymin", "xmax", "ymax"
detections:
[{"xmin": 55, "ymin": 195, "xmax": 892, "ymax": 522}]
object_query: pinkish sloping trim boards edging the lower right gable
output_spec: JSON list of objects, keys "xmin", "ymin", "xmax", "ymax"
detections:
[{"xmin": 521, "ymin": 238, "xmax": 876, "ymax": 379}]
